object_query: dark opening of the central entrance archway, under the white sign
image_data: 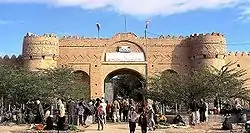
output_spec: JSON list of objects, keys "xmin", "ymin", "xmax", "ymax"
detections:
[{"xmin": 104, "ymin": 68, "xmax": 146, "ymax": 102}]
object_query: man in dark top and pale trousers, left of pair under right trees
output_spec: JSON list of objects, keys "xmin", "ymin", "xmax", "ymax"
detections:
[{"xmin": 190, "ymin": 99, "xmax": 199, "ymax": 125}]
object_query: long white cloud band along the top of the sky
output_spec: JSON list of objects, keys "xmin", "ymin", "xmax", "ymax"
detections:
[{"xmin": 0, "ymin": 0, "xmax": 250, "ymax": 17}]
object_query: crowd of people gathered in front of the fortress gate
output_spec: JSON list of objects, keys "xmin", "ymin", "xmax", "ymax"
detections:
[{"xmin": 0, "ymin": 98, "xmax": 245, "ymax": 133}]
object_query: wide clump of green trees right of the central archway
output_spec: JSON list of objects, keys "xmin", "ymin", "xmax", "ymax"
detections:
[{"xmin": 147, "ymin": 63, "xmax": 250, "ymax": 107}]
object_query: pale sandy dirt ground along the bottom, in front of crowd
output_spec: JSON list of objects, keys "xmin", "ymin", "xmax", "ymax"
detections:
[{"xmin": 0, "ymin": 123, "xmax": 244, "ymax": 133}]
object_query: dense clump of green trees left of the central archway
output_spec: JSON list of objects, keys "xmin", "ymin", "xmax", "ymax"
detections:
[{"xmin": 0, "ymin": 65, "xmax": 90, "ymax": 104}]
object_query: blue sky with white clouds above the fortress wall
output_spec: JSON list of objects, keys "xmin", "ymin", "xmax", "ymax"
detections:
[{"xmin": 0, "ymin": 0, "xmax": 250, "ymax": 55}]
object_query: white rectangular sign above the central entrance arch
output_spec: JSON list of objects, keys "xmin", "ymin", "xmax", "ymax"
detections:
[{"xmin": 106, "ymin": 53, "xmax": 145, "ymax": 62}]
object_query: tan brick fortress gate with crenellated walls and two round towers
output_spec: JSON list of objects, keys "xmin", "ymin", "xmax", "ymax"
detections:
[{"xmin": 0, "ymin": 32, "xmax": 250, "ymax": 98}]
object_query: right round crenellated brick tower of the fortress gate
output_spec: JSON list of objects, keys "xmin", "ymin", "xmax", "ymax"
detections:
[{"xmin": 190, "ymin": 33, "xmax": 226, "ymax": 70}]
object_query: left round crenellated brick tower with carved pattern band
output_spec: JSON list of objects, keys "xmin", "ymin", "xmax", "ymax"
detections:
[{"xmin": 22, "ymin": 33, "xmax": 59, "ymax": 71}]
